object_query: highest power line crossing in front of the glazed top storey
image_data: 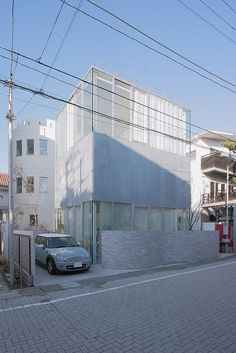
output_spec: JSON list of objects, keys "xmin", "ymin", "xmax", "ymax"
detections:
[{"xmin": 0, "ymin": 46, "xmax": 236, "ymax": 142}]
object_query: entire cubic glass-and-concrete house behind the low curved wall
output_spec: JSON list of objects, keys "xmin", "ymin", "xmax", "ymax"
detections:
[{"xmin": 55, "ymin": 67, "xmax": 191, "ymax": 263}]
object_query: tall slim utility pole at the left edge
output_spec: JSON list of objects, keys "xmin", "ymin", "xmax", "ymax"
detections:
[{"xmin": 6, "ymin": 74, "xmax": 15, "ymax": 288}]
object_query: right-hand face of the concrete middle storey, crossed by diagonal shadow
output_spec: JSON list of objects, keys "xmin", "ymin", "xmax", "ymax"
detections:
[{"xmin": 94, "ymin": 133, "xmax": 190, "ymax": 208}]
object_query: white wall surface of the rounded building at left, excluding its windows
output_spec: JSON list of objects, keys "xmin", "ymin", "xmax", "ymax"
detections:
[{"xmin": 13, "ymin": 119, "xmax": 55, "ymax": 230}]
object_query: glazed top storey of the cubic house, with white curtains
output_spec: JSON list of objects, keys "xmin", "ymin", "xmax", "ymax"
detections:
[{"xmin": 56, "ymin": 67, "xmax": 191, "ymax": 158}]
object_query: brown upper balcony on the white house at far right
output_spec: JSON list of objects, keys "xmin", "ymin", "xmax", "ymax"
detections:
[{"xmin": 201, "ymin": 154, "xmax": 235, "ymax": 183}]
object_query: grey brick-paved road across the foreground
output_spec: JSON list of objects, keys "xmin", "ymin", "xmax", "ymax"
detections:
[{"xmin": 0, "ymin": 258, "xmax": 236, "ymax": 353}]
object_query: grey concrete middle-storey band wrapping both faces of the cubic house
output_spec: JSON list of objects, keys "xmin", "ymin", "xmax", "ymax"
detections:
[{"xmin": 59, "ymin": 133, "xmax": 190, "ymax": 208}]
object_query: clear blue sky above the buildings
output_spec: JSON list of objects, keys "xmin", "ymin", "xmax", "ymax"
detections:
[{"xmin": 0, "ymin": 0, "xmax": 236, "ymax": 172}]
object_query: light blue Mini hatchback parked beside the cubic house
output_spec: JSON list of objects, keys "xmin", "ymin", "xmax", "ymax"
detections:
[{"xmin": 35, "ymin": 233, "xmax": 92, "ymax": 274}]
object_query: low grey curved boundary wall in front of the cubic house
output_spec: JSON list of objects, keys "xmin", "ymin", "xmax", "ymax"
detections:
[{"xmin": 102, "ymin": 231, "xmax": 219, "ymax": 269}]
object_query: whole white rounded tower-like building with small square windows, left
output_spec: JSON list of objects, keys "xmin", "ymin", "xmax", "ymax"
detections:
[{"xmin": 13, "ymin": 119, "xmax": 55, "ymax": 230}]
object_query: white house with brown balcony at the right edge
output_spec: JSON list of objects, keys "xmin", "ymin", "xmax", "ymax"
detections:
[{"xmin": 191, "ymin": 131, "xmax": 236, "ymax": 229}]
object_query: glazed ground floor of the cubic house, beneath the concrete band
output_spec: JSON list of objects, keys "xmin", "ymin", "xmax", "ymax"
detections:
[{"xmin": 56, "ymin": 201, "xmax": 189, "ymax": 263}]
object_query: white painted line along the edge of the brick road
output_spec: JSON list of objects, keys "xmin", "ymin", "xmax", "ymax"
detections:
[{"xmin": 0, "ymin": 261, "xmax": 236, "ymax": 313}]
